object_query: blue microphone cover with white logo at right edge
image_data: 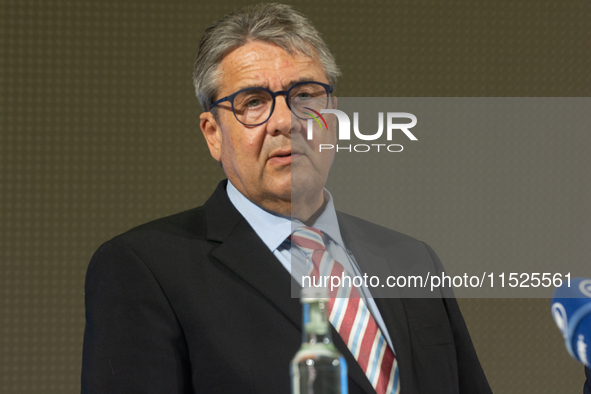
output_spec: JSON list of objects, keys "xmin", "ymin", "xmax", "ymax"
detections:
[{"xmin": 551, "ymin": 278, "xmax": 591, "ymax": 368}]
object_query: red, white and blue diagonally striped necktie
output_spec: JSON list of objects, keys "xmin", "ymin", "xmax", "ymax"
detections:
[{"xmin": 291, "ymin": 227, "xmax": 400, "ymax": 394}]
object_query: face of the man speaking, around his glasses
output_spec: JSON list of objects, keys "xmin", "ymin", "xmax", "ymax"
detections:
[{"xmin": 201, "ymin": 41, "xmax": 336, "ymax": 215}]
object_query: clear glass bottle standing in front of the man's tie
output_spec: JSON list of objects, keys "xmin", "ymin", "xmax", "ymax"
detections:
[{"xmin": 290, "ymin": 288, "xmax": 348, "ymax": 394}]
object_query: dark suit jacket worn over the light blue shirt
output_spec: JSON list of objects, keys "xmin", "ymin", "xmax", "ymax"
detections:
[{"xmin": 82, "ymin": 181, "xmax": 491, "ymax": 394}]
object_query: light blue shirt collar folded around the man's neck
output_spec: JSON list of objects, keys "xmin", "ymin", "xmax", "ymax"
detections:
[{"xmin": 226, "ymin": 180, "xmax": 345, "ymax": 252}]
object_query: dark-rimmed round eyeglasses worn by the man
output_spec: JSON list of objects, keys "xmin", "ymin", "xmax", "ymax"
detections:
[{"xmin": 209, "ymin": 81, "xmax": 334, "ymax": 126}]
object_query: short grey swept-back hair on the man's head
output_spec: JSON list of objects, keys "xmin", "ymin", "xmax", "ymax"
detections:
[{"xmin": 193, "ymin": 3, "xmax": 340, "ymax": 112}]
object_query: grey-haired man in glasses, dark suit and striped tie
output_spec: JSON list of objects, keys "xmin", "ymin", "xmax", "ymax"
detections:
[{"xmin": 82, "ymin": 5, "xmax": 491, "ymax": 394}]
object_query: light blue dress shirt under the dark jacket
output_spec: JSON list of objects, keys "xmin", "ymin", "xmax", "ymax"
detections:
[{"xmin": 226, "ymin": 181, "xmax": 396, "ymax": 354}]
